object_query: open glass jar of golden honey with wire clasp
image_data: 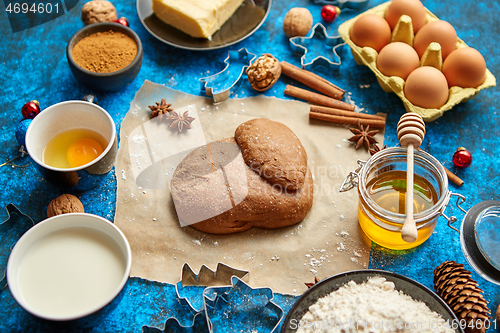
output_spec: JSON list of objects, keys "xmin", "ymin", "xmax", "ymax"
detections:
[{"xmin": 341, "ymin": 147, "xmax": 458, "ymax": 250}]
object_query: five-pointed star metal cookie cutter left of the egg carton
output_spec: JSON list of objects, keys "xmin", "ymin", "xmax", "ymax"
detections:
[{"xmin": 290, "ymin": 23, "xmax": 346, "ymax": 70}]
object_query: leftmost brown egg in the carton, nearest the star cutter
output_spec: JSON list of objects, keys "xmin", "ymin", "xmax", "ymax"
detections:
[{"xmin": 349, "ymin": 14, "xmax": 391, "ymax": 52}]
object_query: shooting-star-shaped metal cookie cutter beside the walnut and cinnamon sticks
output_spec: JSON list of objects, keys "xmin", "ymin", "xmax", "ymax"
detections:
[{"xmin": 200, "ymin": 48, "xmax": 256, "ymax": 103}]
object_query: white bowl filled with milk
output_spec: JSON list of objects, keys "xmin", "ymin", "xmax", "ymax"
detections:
[{"xmin": 7, "ymin": 213, "xmax": 132, "ymax": 321}]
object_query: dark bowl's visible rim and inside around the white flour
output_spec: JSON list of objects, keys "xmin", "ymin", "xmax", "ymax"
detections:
[{"xmin": 281, "ymin": 269, "xmax": 463, "ymax": 333}]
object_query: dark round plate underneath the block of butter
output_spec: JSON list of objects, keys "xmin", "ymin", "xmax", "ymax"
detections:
[{"xmin": 137, "ymin": 0, "xmax": 272, "ymax": 50}]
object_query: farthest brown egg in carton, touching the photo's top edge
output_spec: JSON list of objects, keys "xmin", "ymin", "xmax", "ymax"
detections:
[{"xmin": 385, "ymin": 0, "xmax": 427, "ymax": 33}]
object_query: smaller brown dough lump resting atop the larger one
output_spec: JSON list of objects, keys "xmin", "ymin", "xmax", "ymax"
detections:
[{"xmin": 234, "ymin": 118, "xmax": 307, "ymax": 190}]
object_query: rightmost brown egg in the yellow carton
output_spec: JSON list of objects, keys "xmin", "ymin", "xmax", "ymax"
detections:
[{"xmin": 443, "ymin": 47, "xmax": 486, "ymax": 88}]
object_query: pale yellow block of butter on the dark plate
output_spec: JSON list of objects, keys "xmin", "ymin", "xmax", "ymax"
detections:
[{"xmin": 153, "ymin": 0, "xmax": 244, "ymax": 39}]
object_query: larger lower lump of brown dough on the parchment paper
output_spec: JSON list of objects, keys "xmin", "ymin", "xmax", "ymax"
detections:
[{"xmin": 171, "ymin": 122, "xmax": 313, "ymax": 234}]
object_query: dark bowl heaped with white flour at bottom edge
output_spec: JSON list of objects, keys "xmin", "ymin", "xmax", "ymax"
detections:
[{"xmin": 281, "ymin": 269, "xmax": 463, "ymax": 333}]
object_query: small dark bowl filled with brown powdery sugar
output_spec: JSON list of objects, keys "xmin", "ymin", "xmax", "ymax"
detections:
[{"xmin": 66, "ymin": 22, "xmax": 143, "ymax": 91}]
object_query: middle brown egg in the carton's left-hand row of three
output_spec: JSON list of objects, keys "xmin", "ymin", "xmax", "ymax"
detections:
[{"xmin": 377, "ymin": 42, "xmax": 420, "ymax": 80}]
